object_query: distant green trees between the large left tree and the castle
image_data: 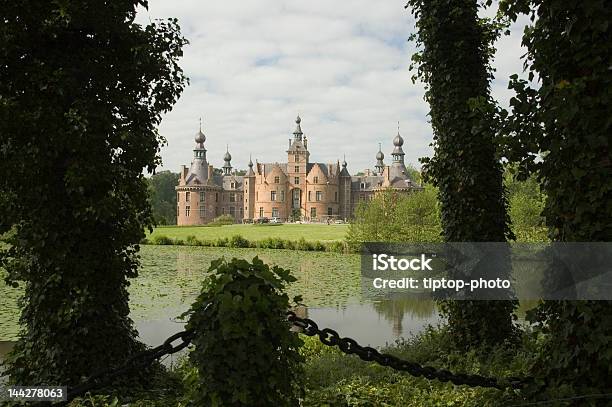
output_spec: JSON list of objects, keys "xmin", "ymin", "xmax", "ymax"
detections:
[{"xmin": 148, "ymin": 171, "xmax": 179, "ymax": 225}]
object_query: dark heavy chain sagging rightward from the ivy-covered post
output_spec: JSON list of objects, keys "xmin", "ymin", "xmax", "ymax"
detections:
[{"xmin": 287, "ymin": 311, "xmax": 531, "ymax": 389}]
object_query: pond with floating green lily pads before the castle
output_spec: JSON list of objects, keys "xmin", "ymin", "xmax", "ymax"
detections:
[{"xmin": 0, "ymin": 246, "xmax": 438, "ymax": 368}]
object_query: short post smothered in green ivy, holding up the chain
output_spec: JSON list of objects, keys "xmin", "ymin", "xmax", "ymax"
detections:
[{"xmin": 187, "ymin": 257, "xmax": 303, "ymax": 406}]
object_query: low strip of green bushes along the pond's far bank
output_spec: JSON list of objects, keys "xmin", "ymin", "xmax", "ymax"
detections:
[{"xmin": 140, "ymin": 235, "xmax": 351, "ymax": 253}]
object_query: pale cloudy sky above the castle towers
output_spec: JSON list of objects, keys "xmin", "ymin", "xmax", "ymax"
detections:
[{"xmin": 138, "ymin": 0, "xmax": 524, "ymax": 173}]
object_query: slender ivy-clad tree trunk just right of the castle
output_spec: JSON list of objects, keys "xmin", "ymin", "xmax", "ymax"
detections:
[{"xmin": 407, "ymin": 0, "xmax": 517, "ymax": 348}]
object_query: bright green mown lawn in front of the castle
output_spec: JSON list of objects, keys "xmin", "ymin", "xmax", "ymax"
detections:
[{"xmin": 147, "ymin": 224, "xmax": 348, "ymax": 242}]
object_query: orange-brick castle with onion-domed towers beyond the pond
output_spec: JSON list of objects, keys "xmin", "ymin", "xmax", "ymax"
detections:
[{"xmin": 176, "ymin": 116, "xmax": 422, "ymax": 225}]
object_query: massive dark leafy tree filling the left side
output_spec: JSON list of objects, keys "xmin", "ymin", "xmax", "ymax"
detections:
[{"xmin": 0, "ymin": 0, "xmax": 186, "ymax": 386}]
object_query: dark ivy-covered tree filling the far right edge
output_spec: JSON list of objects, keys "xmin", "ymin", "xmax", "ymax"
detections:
[{"xmin": 501, "ymin": 0, "xmax": 612, "ymax": 396}]
